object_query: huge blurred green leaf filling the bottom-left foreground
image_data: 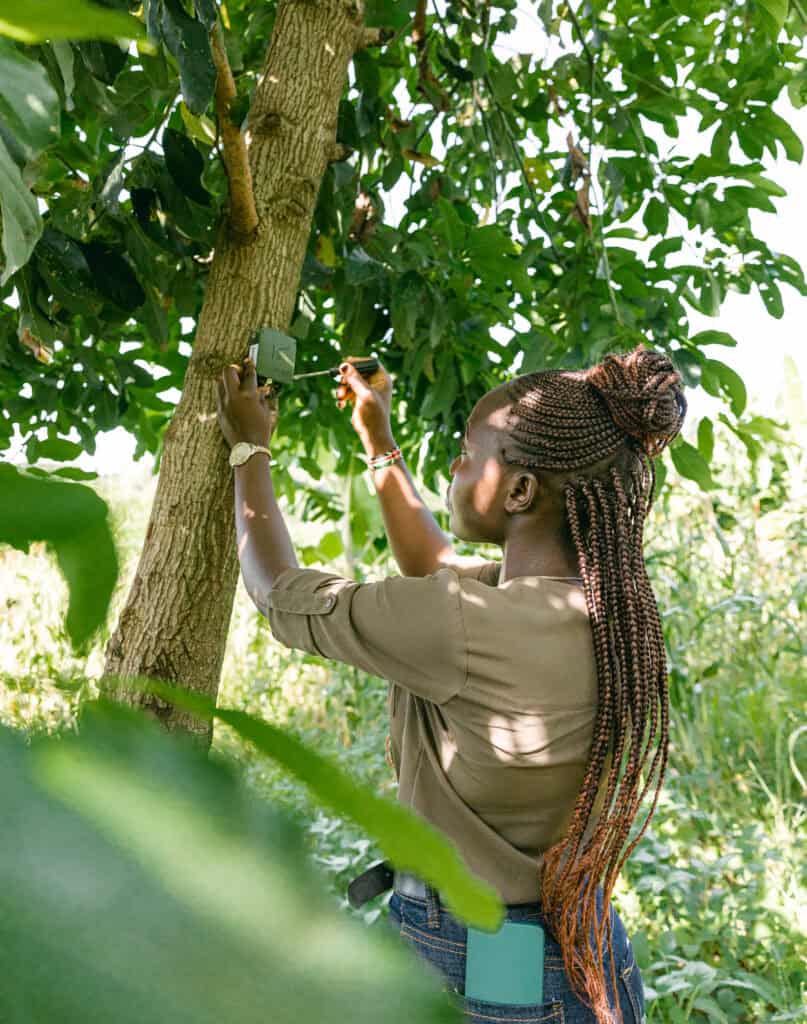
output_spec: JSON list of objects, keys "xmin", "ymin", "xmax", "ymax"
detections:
[{"xmin": 0, "ymin": 703, "xmax": 461, "ymax": 1024}]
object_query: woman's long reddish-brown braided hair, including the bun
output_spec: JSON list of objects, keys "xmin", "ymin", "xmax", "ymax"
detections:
[{"xmin": 503, "ymin": 345, "xmax": 686, "ymax": 1024}]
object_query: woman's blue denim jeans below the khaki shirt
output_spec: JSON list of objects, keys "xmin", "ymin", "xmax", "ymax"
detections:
[{"xmin": 389, "ymin": 888, "xmax": 645, "ymax": 1024}]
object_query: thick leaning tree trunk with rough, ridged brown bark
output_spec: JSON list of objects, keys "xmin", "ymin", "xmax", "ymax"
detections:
[{"xmin": 104, "ymin": 0, "xmax": 364, "ymax": 743}]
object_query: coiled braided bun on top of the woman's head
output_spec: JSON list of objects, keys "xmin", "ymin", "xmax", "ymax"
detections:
[{"xmin": 586, "ymin": 345, "xmax": 686, "ymax": 458}]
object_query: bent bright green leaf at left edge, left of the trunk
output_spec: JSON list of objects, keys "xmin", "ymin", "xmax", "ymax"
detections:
[{"xmin": 0, "ymin": 462, "xmax": 118, "ymax": 650}]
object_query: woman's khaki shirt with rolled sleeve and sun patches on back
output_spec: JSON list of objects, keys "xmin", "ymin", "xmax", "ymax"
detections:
[{"xmin": 267, "ymin": 562, "xmax": 607, "ymax": 903}]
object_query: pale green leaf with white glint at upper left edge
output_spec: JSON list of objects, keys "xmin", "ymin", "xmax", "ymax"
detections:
[{"xmin": 0, "ymin": 39, "xmax": 59, "ymax": 160}]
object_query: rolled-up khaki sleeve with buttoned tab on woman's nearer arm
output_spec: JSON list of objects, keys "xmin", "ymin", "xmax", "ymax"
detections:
[{"xmin": 263, "ymin": 568, "xmax": 468, "ymax": 703}]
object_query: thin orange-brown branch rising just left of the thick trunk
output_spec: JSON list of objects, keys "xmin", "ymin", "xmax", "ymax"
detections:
[{"xmin": 210, "ymin": 23, "xmax": 258, "ymax": 245}]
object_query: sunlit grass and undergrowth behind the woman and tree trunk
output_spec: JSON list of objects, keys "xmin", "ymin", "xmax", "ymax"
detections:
[{"xmin": 0, "ymin": 411, "xmax": 807, "ymax": 1024}]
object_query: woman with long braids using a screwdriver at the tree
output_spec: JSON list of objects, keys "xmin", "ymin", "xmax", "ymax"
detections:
[{"xmin": 219, "ymin": 346, "xmax": 686, "ymax": 1024}]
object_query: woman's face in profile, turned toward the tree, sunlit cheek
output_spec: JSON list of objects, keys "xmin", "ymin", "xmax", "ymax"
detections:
[{"xmin": 447, "ymin": 389, "xmax": 509, "ymax": 544}]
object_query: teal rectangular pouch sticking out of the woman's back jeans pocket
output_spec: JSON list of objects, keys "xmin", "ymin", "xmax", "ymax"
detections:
[{"xmin": 465, "ymin": 921, "xmax": 544, "ymax": 1005}]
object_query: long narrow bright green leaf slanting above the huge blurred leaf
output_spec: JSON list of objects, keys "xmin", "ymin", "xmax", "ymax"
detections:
[{"xmin": 140, "ymin": 680, "xmax": 503, "ymax": 930}]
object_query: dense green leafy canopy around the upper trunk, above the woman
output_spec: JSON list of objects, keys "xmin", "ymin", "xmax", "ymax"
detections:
[{"xmin": 0, "ymin": 0, "xmax": 807, "ymax": 544}]
